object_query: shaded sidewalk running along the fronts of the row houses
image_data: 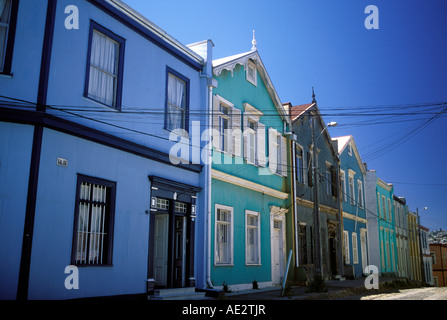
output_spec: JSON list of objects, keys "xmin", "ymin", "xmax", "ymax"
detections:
[{"xmin": 220, "ymin": 277, "xmax": 395, "ymax": 300}]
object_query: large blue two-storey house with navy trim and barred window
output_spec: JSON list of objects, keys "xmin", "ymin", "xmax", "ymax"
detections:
[{"xmin": 0, "ymin": 0, "xmax": 213, "ymax": 299}]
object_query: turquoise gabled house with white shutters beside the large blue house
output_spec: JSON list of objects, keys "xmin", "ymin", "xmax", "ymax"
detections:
[{"xmin": 208, "ymin": 41, "xmax": 290, "ymax": 291}]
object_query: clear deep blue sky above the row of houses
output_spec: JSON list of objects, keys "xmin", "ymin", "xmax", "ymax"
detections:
[{"xmin": 125, "ymin": 0, "xmax": 447, "ymax": 229}]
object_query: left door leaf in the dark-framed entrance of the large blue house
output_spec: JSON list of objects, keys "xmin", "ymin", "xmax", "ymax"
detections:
[{"xmin": 154, "ymin": 214, "xmax": 169, "ymax": 287}]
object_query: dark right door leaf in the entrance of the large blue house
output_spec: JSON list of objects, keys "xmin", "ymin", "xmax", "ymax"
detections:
[{"xmin": 173, "ymin": 216, "xmax": 185, "ymax": 288}]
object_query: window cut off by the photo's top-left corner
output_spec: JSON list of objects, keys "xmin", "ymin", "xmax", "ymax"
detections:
[{"xmin": 0, "ymin": 0, "xmax": 19, "ymax": 74}]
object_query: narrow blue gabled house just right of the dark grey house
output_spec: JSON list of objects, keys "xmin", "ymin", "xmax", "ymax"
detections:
[{"xmin": 333, "ymin": 136, "xmax": 368, "ymax": 278}]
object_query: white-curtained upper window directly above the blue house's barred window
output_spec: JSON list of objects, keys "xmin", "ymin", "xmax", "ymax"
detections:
[{"xmin": 84, "ymin": 21, "xmax": 125, "ymax": 109}]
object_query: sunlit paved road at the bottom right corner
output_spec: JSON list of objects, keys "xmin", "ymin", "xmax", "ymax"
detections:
[{"xmin": 342, "ymin": 287, "xmax": 447, "ymax": 300}]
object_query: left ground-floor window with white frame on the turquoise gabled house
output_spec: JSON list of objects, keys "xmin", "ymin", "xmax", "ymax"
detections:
[{"xmin": 215, "ymin": 205, "xmax": 233, "ymax": 265}]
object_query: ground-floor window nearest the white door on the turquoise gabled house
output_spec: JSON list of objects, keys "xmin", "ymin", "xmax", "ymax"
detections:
[{"xmin": 245, "ymin": 210, "xmax": 261, "ymax": 264}]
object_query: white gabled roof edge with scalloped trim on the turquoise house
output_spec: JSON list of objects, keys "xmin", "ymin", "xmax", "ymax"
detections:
[{"xmin": 213, "ymin": 50, "xmax": 290, "ymax": 123}]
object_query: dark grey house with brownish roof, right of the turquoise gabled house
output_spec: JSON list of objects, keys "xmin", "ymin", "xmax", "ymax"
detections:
[{"xmin": 285, "ymin": 97, "xmax": 343, "ymax": 281}]
